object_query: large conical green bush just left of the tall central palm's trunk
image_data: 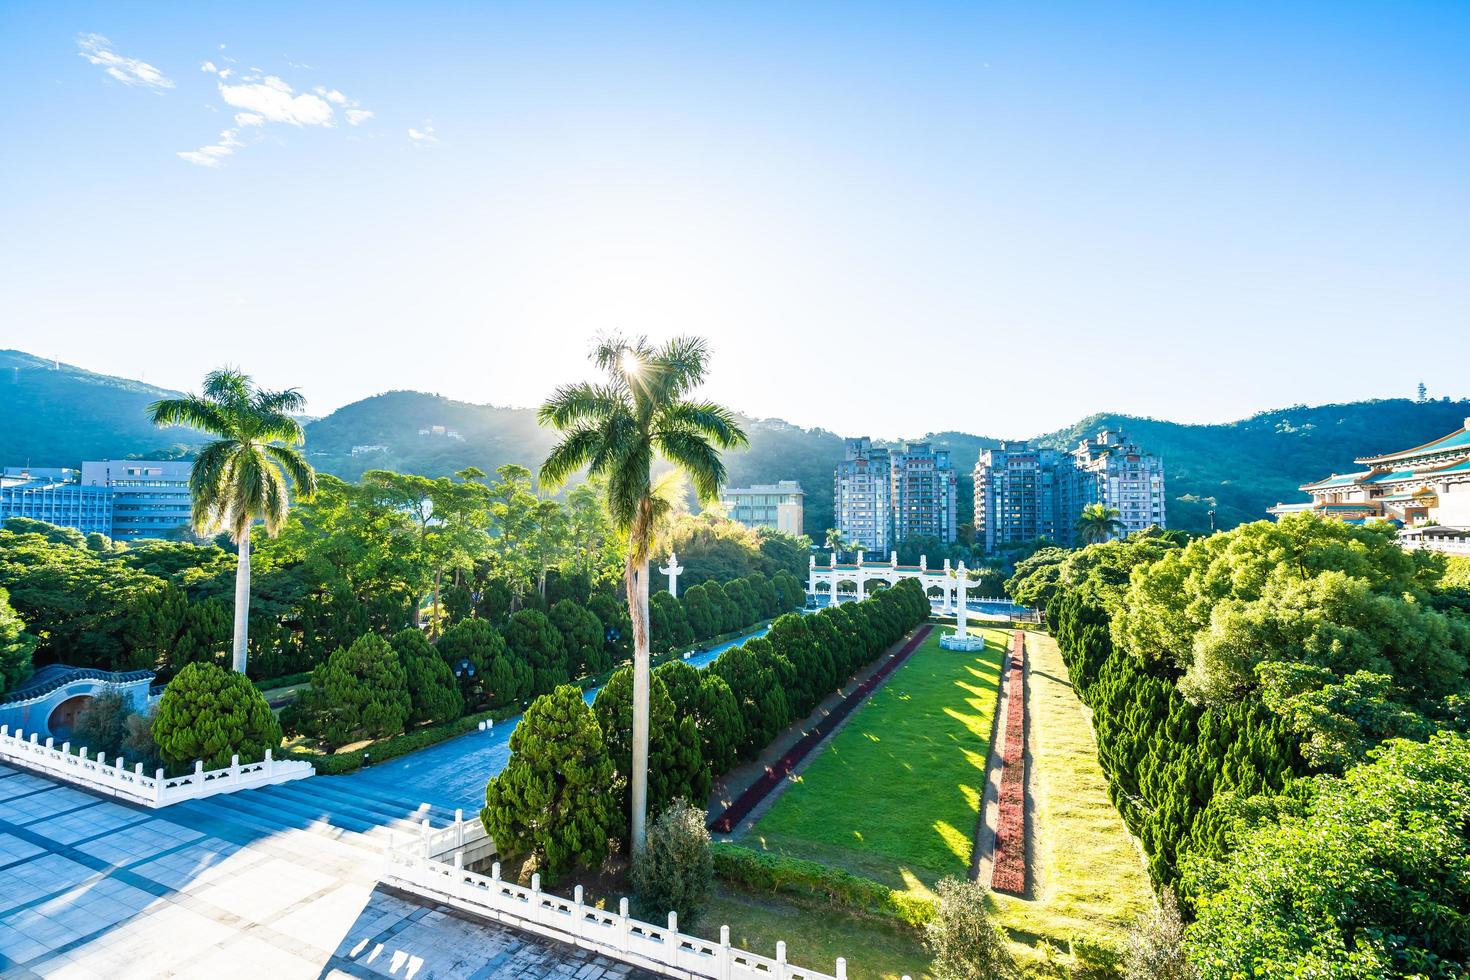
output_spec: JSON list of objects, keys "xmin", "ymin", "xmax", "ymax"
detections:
[{"xmin": 479, "ymin": 685, "xmax": 620, "ymax": 874}]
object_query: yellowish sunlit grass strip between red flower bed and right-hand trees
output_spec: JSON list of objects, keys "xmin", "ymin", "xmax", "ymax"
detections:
[{"xmin": 995, "ymin": 633, "xmax": 1154, "ymax": 949}]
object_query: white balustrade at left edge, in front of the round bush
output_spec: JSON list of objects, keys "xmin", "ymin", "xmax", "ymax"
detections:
[{"xmin": 0, "ymin": 724, "xmax": 316, "ymax": 808}]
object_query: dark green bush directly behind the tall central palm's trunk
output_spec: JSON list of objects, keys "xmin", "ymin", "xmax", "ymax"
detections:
[{"xmin": 592, "ymin": 664, "xmax": 710, "ymax": 834}]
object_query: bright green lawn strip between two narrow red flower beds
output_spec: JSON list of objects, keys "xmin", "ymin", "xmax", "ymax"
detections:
[{"xmin": 744, "ymin": 629, "xmax": 1005, "ymax": 892}]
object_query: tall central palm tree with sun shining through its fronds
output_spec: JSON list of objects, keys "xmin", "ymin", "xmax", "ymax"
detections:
[{"xmin": 537, "ymin": 336, "xmax": 747, "ymax": 852}]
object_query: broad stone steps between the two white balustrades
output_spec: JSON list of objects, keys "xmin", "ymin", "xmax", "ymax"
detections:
[{"xmin": 163, "ymin": 776, "xmax": 464, "ymax": 854}]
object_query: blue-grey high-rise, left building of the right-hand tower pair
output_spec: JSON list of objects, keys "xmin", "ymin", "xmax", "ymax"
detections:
[{"xmin": 975, "ymin": 441, "xmax": 1072, "ymax": 552}]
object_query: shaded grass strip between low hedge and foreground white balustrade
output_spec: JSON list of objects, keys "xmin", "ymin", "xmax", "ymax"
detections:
[{"xmin": 694, "ymin": 887, "xmax": 929, "ymax": 980}]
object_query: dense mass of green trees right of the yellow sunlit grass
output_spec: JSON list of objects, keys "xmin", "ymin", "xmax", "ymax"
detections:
[{"xmin": 1007, "ymin": 516, "xmax": 1470, "ymax": 977}]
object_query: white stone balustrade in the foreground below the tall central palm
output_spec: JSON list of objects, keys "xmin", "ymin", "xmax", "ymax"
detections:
[{"xmin": 379, "ymin": 834, "xmax": 847, "ymax": 980}]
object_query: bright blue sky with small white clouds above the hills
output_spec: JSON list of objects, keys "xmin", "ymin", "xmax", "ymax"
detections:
[{"xmin": 0, "ymin": 0, "xmax": 1470, "ymax": 438}]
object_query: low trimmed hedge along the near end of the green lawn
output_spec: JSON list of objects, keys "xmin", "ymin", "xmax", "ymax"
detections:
[{"xmin": 711, "ymin": 843, "xmax": 936, "ymax": 929}]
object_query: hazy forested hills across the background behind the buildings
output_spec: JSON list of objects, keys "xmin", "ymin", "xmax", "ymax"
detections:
[{"xmin": 0, "ymin": 351, "xmax": 1470, "ymax": 538}]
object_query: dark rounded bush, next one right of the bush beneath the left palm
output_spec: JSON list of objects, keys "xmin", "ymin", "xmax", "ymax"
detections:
[{"xmin": 310, "ymin": 633, "xmax": 413, "ymax": 748}]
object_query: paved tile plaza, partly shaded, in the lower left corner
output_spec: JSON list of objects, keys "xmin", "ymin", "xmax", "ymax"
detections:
[{"xmin": 0, "ymin": 765, "xmax": 648, "ymax": 980}]
